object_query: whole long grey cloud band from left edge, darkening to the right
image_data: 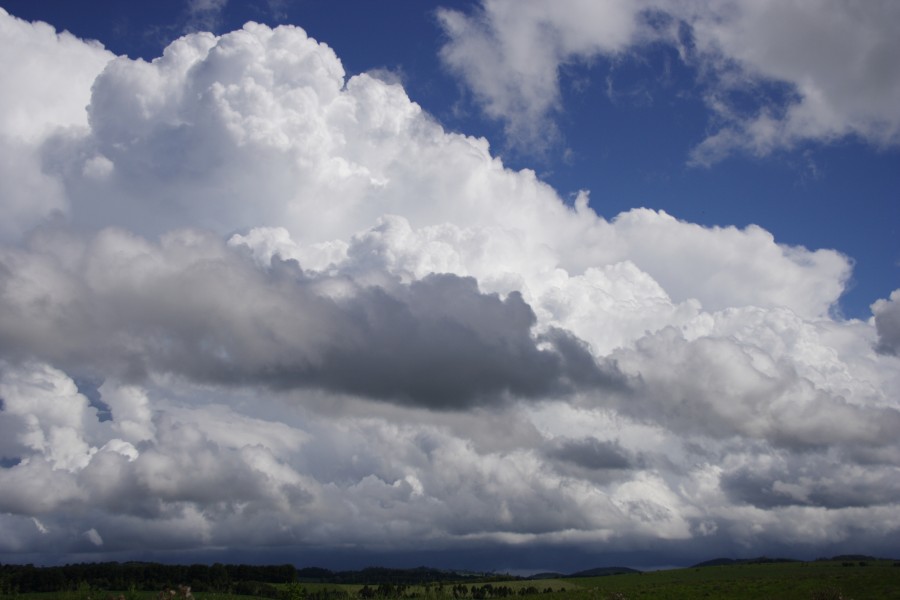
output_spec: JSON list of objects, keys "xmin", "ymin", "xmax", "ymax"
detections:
[{"xmin": 0, "ymin": 230, "xmax": 621, "ymax": 409}]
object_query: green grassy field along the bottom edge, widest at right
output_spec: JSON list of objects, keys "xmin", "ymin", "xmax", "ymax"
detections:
[{"xmin": 0, "ymin": 561, "xmax": 900, "ymax": 600}]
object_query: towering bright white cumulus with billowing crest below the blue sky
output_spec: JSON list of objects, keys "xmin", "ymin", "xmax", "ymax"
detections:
[{"xmin": 7, "ymin": 11, "xmax": 849, "ymax": 324}]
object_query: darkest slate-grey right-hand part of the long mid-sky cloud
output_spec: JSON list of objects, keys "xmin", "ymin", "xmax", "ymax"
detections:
[{"xmin": 292, "ymin": 275, "xmax": 613, "ymax": 408}]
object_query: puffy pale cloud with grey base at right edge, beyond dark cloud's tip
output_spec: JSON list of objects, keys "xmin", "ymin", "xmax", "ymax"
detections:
[{"xmin": 613, "ymin": 311, "xmax": 900, "ymax": 451}]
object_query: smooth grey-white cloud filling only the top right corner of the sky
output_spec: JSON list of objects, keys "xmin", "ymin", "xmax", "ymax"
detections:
[{"xmin": 688, "ymin": 0, "xmax": 900, "ymax": 164}]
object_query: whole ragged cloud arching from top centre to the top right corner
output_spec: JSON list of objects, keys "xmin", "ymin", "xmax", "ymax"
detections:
[{"xmin": 439, "ymin": 0, "xmax": 900, "ymax": 166}]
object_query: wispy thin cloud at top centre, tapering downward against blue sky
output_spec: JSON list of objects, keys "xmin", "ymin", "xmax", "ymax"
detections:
[{"xmin": 437, "ymin": 0, "xmax": 643, "ymax": 144}]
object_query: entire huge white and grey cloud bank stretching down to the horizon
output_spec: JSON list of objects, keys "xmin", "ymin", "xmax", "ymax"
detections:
[{"xmin": 0, "ymin": 2, "xmax": 900, "ymax": 568}]
